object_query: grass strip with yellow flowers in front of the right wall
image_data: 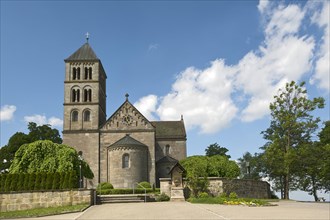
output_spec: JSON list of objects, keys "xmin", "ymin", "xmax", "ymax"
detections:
[{"xmin": 188, "ymin": 197, "xmax": 271, "ymax": 206}]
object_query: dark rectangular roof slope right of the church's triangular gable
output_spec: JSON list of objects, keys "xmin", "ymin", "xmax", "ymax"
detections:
[{"xmin": 151, "ymin": 120, "xmax": 186, "ymax": 139}]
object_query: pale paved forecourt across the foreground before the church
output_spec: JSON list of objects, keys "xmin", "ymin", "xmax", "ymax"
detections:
[{"xmin": 18, "ymin": 201, "xmax": 330, "ymax": 220}]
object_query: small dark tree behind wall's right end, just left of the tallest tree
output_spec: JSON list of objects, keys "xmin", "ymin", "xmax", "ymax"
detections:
[{"xmin": 238, "ymin": 152, "xmax": 262, "ymax": 180}]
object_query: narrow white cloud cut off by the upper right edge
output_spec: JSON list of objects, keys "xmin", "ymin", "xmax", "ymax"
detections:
[{"xmin": 310, "ymin": 1, "xmax": 330, "ymax": 91}]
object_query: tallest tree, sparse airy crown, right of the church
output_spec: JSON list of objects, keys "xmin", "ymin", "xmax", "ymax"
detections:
[{"xmin": 262, "ymin": 81, "xmax": 324, "ymax": 199}]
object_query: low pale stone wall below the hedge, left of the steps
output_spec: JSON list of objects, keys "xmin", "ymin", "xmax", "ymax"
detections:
[{"xmin": 0, "ymin": 189, "xmax": 94, "ymax": 212}]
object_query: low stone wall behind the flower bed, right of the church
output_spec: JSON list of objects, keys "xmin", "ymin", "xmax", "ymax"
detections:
[{"xmin": 159, "ymin": 177, "xmax": 271, "ymax": 199}]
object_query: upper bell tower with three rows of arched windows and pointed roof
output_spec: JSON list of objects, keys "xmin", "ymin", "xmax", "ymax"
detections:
[{"xmin": 63, "ymin": 37, "xmax": 107, "ymax": 132}]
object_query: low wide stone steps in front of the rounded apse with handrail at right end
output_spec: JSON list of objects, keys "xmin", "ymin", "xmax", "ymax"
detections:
[{"xmin": 97, "ymin": 194, "xmax": 151, "ymax": 204}]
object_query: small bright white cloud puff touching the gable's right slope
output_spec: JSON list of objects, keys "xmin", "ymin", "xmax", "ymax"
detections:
[{"xmin": 134, "ymin": 95, "xmax": 157, "ymax": 121}]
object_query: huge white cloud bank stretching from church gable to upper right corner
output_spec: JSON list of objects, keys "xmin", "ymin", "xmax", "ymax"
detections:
[{"xmin": 135, "ymin": 1, "xmax": 329, "ymax": 133}]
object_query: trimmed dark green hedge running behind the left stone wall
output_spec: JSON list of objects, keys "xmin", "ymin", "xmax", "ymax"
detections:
[{"xmin": 0, "ymin": 172, "xmax": 79, "ymax": 192}]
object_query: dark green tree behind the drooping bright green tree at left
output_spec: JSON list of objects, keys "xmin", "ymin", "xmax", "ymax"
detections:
[{"xmin": 0, "ymin": 122, "xmax": 62, "ymax": 172}]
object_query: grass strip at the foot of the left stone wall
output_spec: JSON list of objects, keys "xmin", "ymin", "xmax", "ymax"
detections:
[{"xmin": 0, "ymin": 204, "xmax": 89, "ymax": 219}]
